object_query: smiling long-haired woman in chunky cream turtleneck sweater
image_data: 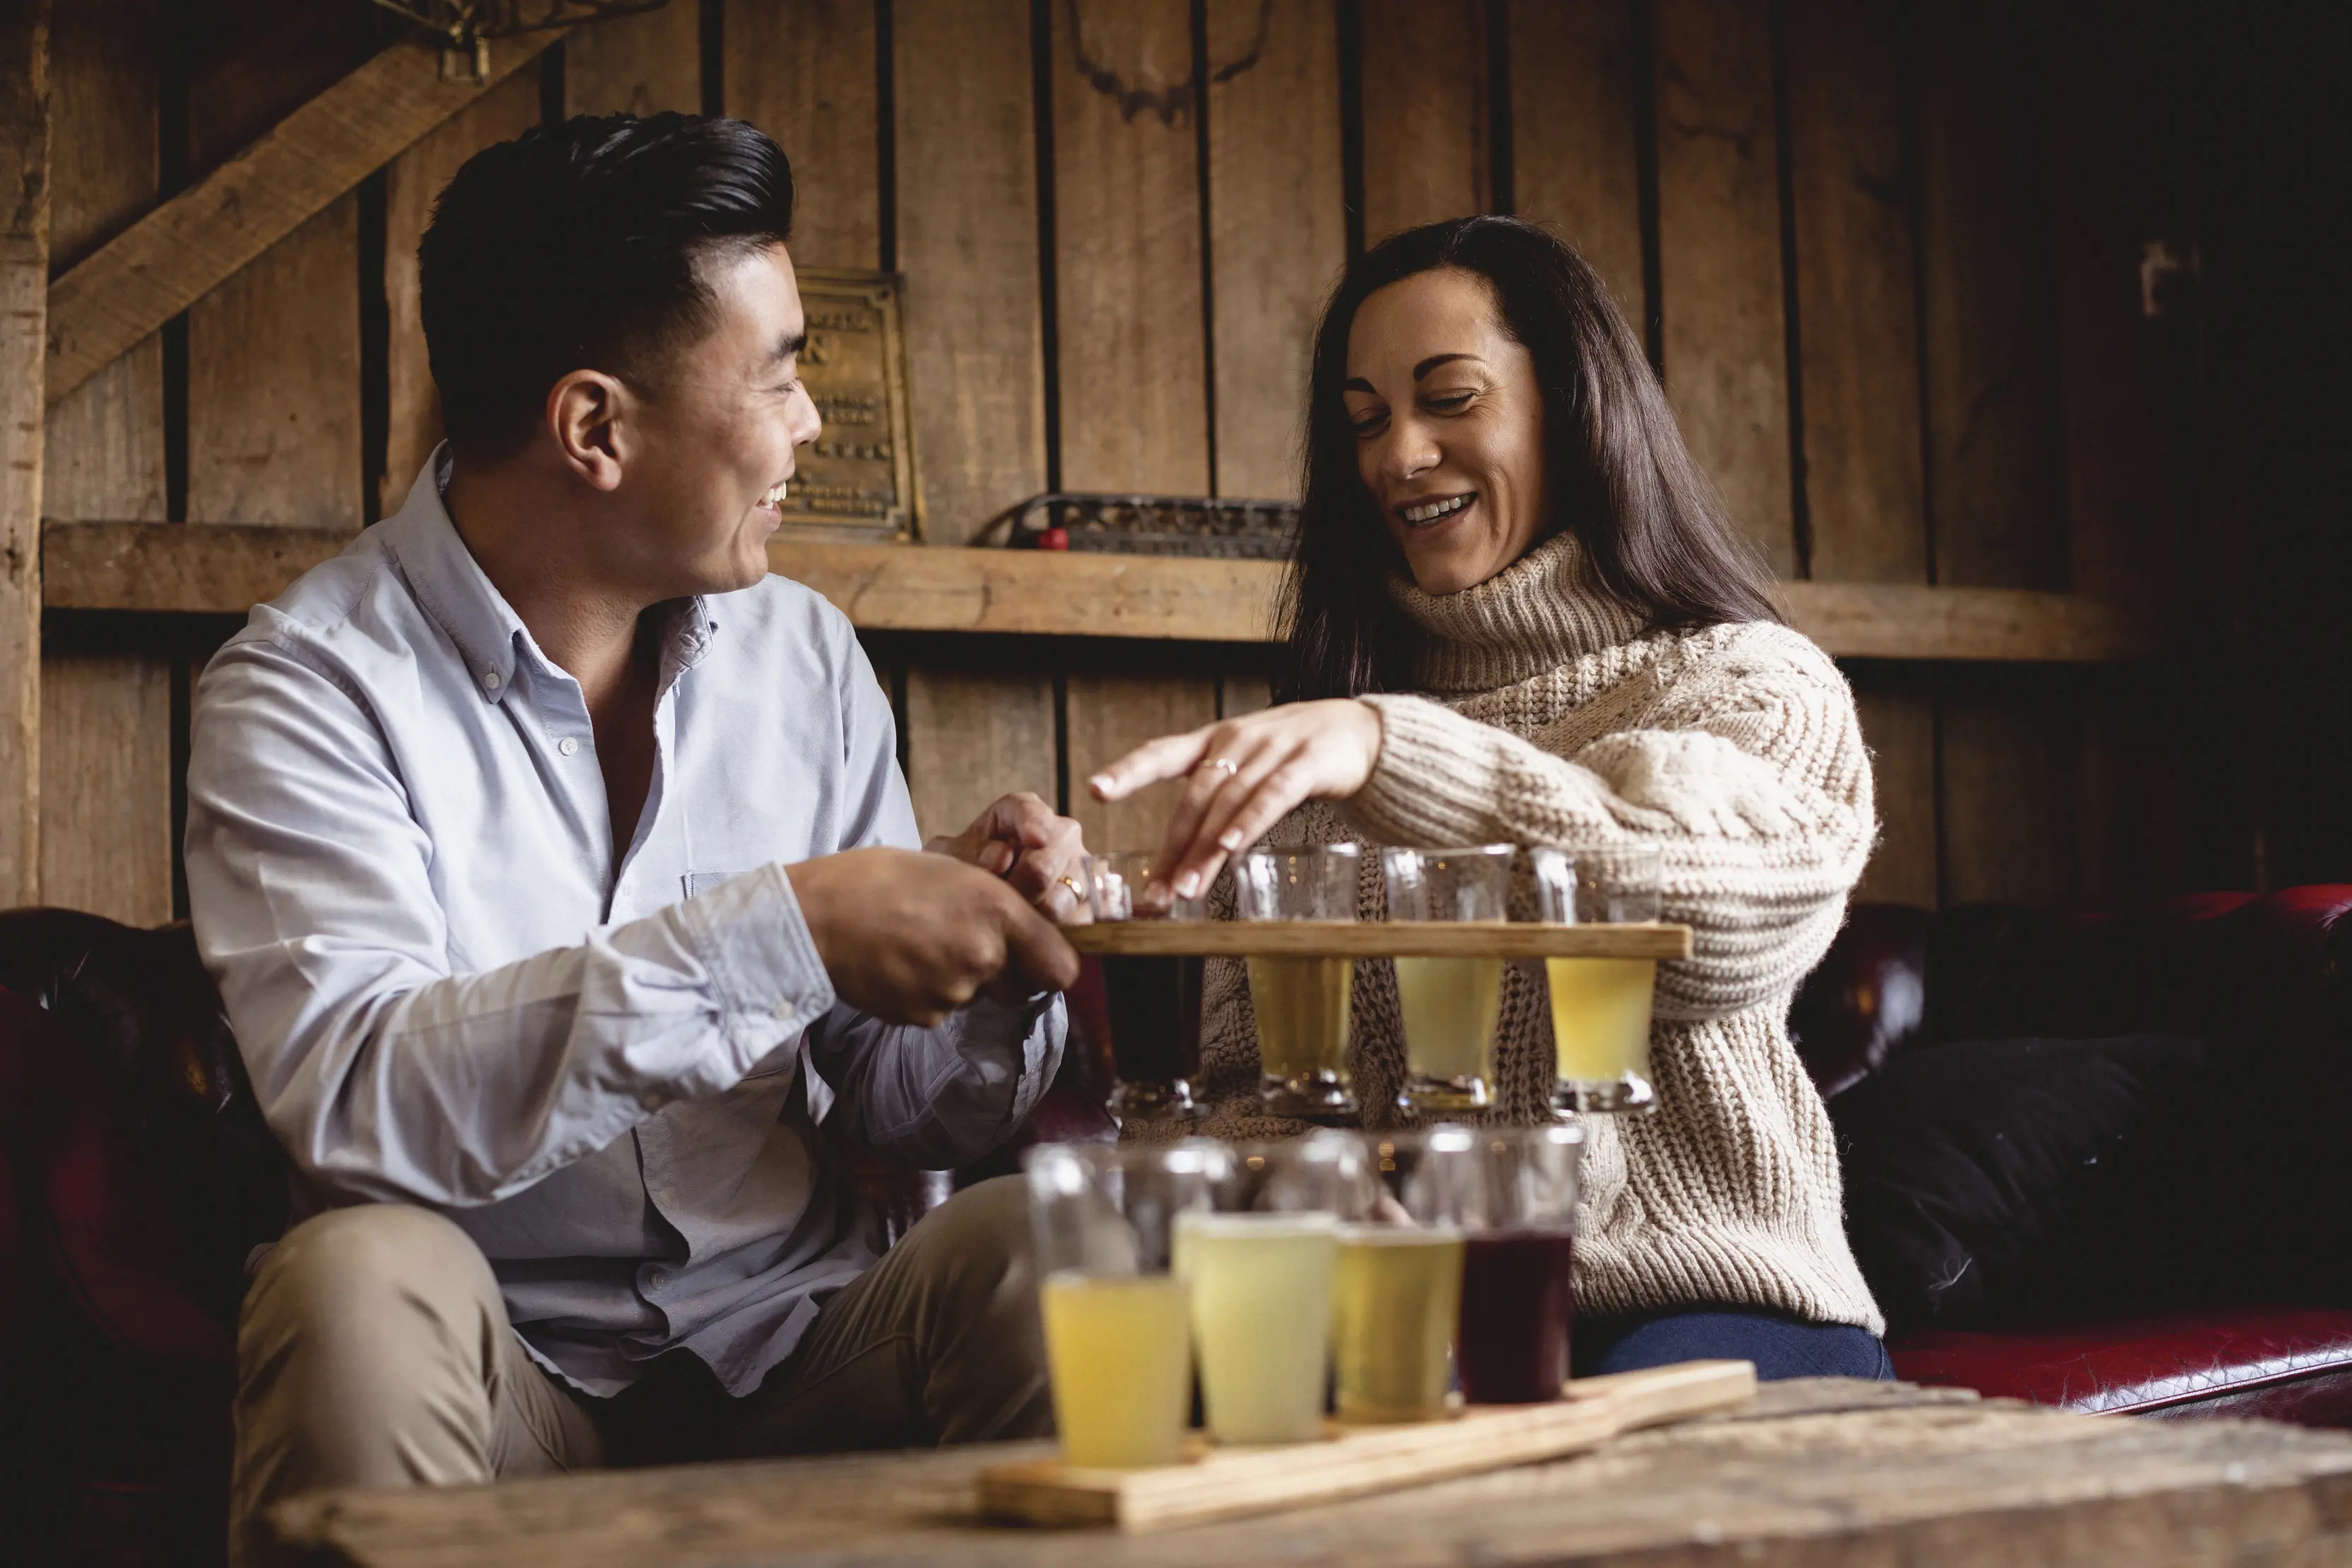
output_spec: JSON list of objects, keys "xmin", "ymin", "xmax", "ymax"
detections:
[{"xmin": 1089, "ymin": 219, "xmax": 1891, "ymax": 1377}]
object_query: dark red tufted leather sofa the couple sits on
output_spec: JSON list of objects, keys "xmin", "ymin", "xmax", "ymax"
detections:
[{"xmin": 0, "ymin": 886, "xmax": 2352, "ymax": 1568}]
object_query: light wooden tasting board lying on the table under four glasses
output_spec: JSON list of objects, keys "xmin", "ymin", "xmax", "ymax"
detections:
[{"xmin": 981, "ymin": 1361, "xmax": 1757, "ymax": 1531}]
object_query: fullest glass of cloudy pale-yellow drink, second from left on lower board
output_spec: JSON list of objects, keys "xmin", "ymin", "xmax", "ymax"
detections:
[{"xmin": 1176, "ymin": 1131, "xmax": 1366, "ymax": 1444}]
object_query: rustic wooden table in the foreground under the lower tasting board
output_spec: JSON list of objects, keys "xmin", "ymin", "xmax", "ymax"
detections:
[{"xmin": 277, "ymin": 1377, "xmax": 2352, "ymax": 1568}]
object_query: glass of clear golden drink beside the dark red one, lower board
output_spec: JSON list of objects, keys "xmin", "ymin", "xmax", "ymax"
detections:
[{"xmin": 1331, "ymin": 1124, "xmax": 1484, "ymax": 1425}]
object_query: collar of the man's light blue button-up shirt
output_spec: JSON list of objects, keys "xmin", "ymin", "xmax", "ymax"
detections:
[{"xmin": 381, "ymin": 442, "xmax": 717, "ymax": 703}]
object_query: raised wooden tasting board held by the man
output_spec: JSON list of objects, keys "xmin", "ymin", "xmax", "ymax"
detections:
[{"xmin": 1061, "ymin": 919, "xmax": 1691, "ymax": 959}]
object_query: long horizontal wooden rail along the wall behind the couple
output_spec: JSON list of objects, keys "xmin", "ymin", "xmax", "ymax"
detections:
[{"xmin": 42, "ymin": 520, "xmax": 2159, "ymax": 663}]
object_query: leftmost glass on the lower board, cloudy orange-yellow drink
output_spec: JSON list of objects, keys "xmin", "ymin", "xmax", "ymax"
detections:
[{"xmin": 1021, "ymin": 1138, "xmax": 1232, "ymax": 1469}]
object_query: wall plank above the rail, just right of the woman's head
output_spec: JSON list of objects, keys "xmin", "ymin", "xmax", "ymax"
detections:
[{"xmin": 1654, "ymin": 0, "xmax": 1797, "ymax": 576}]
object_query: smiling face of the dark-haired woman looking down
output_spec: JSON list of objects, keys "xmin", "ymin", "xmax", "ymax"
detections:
[{"xmin": 1341, "ymin": 268, "xmax": 1550, "ymax": 594}]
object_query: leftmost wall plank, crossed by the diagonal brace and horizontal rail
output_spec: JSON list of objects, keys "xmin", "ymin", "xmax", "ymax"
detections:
[{"xmin": 40, "ymin": 0, "xmax": 172, "ymax": 926}]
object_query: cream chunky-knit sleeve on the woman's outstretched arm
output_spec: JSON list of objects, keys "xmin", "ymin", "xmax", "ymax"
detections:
[{"xmin": 1345, "ymin": 628, "xmax": 1875, "ymax": 1020}]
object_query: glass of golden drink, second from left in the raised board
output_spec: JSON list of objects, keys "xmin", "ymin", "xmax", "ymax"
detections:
[{"xmin": 1232, "ymin": 844, "xmax": 1364, "ymax": 1121}]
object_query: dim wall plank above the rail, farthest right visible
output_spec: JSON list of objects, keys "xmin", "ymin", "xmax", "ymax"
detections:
[{"xmin": 1919, "ymin": 0, "xmax": 2067, "ymax": 587}]
